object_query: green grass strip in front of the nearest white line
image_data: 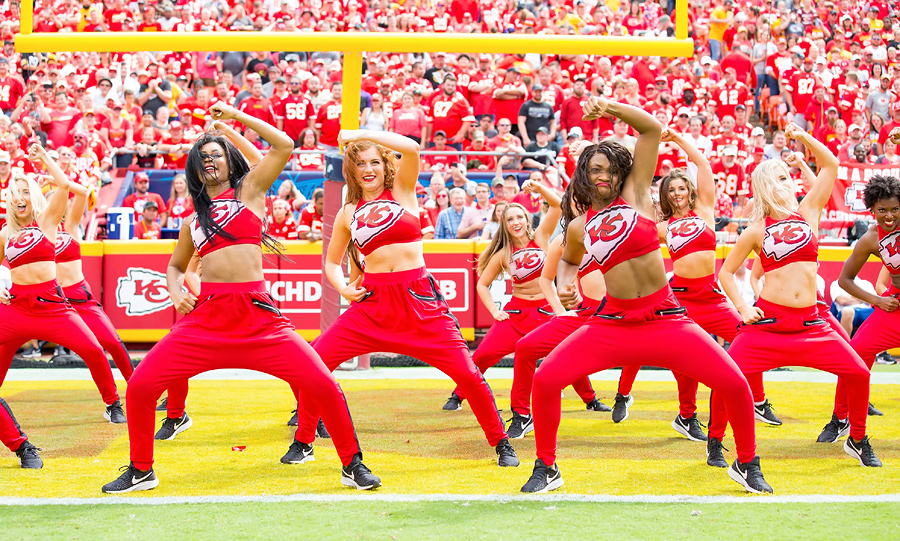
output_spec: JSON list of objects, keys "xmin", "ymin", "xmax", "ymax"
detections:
[{"xmin": 0, "ymin": 500, "xmax": 900, "ymax": 540}]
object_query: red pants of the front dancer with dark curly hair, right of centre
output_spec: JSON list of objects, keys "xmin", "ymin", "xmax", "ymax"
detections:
[{"xmin": 532, "ymin": 286, "xmax": 756, "ymax": 465}]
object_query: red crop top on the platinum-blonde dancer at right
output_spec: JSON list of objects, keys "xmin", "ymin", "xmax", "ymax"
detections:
[{"xmin": 759, "ymin": 212, "xmax": 819, "ymax": 272}]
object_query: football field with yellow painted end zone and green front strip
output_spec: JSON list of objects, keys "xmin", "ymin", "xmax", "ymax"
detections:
[{"xmin": 0, "ymin": 366, "xmax": 900, "ymax": 539}]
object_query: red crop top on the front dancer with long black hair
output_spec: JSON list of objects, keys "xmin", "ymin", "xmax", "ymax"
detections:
[{"xmin": 191, "ymin": 188, "xmax": 265, "ymax": 257}]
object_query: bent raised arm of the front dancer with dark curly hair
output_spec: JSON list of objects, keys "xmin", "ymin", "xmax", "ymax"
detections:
[{"xmin": 582, "ymin": 96, "xmax": 662, "ymax": 199}]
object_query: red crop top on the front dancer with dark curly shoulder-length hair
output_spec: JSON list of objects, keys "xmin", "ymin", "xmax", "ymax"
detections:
[{"xmin": 582, "ymin": 197, "xmax": 659, "ymax": 274}]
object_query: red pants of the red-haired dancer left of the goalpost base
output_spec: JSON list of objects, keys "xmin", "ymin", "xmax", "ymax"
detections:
[{"xmin": 296, "ymin": 267, "xmax": 506, "ymax": 446}]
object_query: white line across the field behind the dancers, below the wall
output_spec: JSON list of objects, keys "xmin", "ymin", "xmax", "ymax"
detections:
[{"xmin": 6, "ymin": 367, "xmax": 900, "ymax": 385}]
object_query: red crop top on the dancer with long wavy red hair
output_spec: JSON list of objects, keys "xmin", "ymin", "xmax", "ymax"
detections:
[{"xmin": 350, "ymin": 190, "xmax": 422, "ymax": 256}]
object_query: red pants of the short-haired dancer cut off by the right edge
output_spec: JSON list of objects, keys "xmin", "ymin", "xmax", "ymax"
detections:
[{"xmin": 829, "ymin": 286, "xmax": 900, "ymax": 419}]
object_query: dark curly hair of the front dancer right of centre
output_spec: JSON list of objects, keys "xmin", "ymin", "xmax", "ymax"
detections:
[{"xmin": 560, "ymin": 141, "xmax": 634, "ymax": 230}]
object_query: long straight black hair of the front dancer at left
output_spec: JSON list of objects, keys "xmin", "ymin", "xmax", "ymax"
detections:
[{"xmin": 184, "ymin": 132, "xmax": 283, "ymax": 256}]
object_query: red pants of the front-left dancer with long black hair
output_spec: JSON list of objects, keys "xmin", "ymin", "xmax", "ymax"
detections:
[{"xmin": 126, "ymin": 282, "xmax": 360, "ymax": 470}]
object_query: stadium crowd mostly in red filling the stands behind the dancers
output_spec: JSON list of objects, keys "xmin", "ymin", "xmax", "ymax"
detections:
[{"xmin": 0, "ymin": 0, "xmax": 900, "ymax": 240}]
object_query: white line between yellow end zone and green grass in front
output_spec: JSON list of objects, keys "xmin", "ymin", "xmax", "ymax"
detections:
[{"xmin": 0, "ymin": 493, "xmax": 900, "ymax": 506}]
